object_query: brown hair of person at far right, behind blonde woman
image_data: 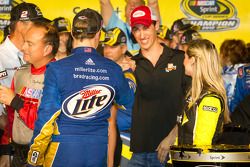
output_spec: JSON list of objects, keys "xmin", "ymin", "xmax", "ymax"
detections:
[{"xmin": 220, "ymin": 39, "xmax": 248, "ymax": 65}]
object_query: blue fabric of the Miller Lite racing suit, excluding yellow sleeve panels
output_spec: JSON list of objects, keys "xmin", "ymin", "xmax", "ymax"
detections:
[{"xmin": 31, "ymin": 47, "xmax": 134, "ymax": 167}]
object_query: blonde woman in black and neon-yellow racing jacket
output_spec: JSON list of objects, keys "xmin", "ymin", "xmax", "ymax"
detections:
[{"xmin": 178, "ymin": 39, "xmax": 230, "ymax": 146}]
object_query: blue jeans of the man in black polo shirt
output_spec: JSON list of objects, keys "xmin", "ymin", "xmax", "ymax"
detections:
[{"xmin": 128, "ymin": 152, "xmax": 165, "ymax": 167}]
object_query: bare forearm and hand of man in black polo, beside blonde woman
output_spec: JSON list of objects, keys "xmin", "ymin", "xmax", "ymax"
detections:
[{"xmin": 156, "ymin": 125, "xmax": 178, "ymax": 163}]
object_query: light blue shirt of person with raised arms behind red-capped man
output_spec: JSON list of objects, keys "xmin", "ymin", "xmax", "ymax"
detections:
[{"xmin": 105, "ymin": 11, "xmax": 140, "ymax": 52}]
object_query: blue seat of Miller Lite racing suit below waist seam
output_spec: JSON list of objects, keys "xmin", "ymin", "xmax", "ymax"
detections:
[{"xmin": 53, "ymin": 136, "xmax": 107, "ymax": 167}]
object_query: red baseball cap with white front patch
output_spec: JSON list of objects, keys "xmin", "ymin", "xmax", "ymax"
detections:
[{"xmin": 130, "ymin": 6, "xmax": 157, "ymax": 27}]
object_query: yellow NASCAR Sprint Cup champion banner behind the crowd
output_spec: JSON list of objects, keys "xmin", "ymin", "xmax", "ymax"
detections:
[{"xmin": 0, "ymin": 0, "xmax": 250, "ymax": 47}]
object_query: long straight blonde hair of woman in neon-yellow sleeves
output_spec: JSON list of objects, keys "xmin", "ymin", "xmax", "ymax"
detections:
[{"xmin": 187, "ymin": 39, "xmax": 230, "ymax": 123}]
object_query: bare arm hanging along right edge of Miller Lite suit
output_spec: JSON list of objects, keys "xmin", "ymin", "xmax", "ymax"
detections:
[{"xmin": 108, "ymin": 105, "xmax": 117, "ymax": 167}]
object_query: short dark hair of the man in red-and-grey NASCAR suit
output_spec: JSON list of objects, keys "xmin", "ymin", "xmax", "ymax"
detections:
[{"xmin": 33, "ymin": 22, "xmax": 59, "ymax": 56}]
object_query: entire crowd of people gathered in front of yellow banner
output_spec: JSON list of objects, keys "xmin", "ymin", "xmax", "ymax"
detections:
[{"xmin": 0, "ymin": 0, "xmax": 250, "ymax": 167}]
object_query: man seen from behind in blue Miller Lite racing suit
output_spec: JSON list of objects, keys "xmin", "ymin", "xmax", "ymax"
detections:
[{"xmin": 28, "ymin": 9, "xmax": 133, "ymax": 167}]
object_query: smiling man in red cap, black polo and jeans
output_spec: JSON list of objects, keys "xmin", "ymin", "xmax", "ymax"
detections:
[{"xmin": 129, "ymin": 6, "xmax": 188, "ymax": 167}]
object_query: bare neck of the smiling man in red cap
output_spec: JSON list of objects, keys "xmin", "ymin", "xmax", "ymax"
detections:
[{"xmin": 141, "ymin": 41, "xmax": 163, "ymax": 66}]
